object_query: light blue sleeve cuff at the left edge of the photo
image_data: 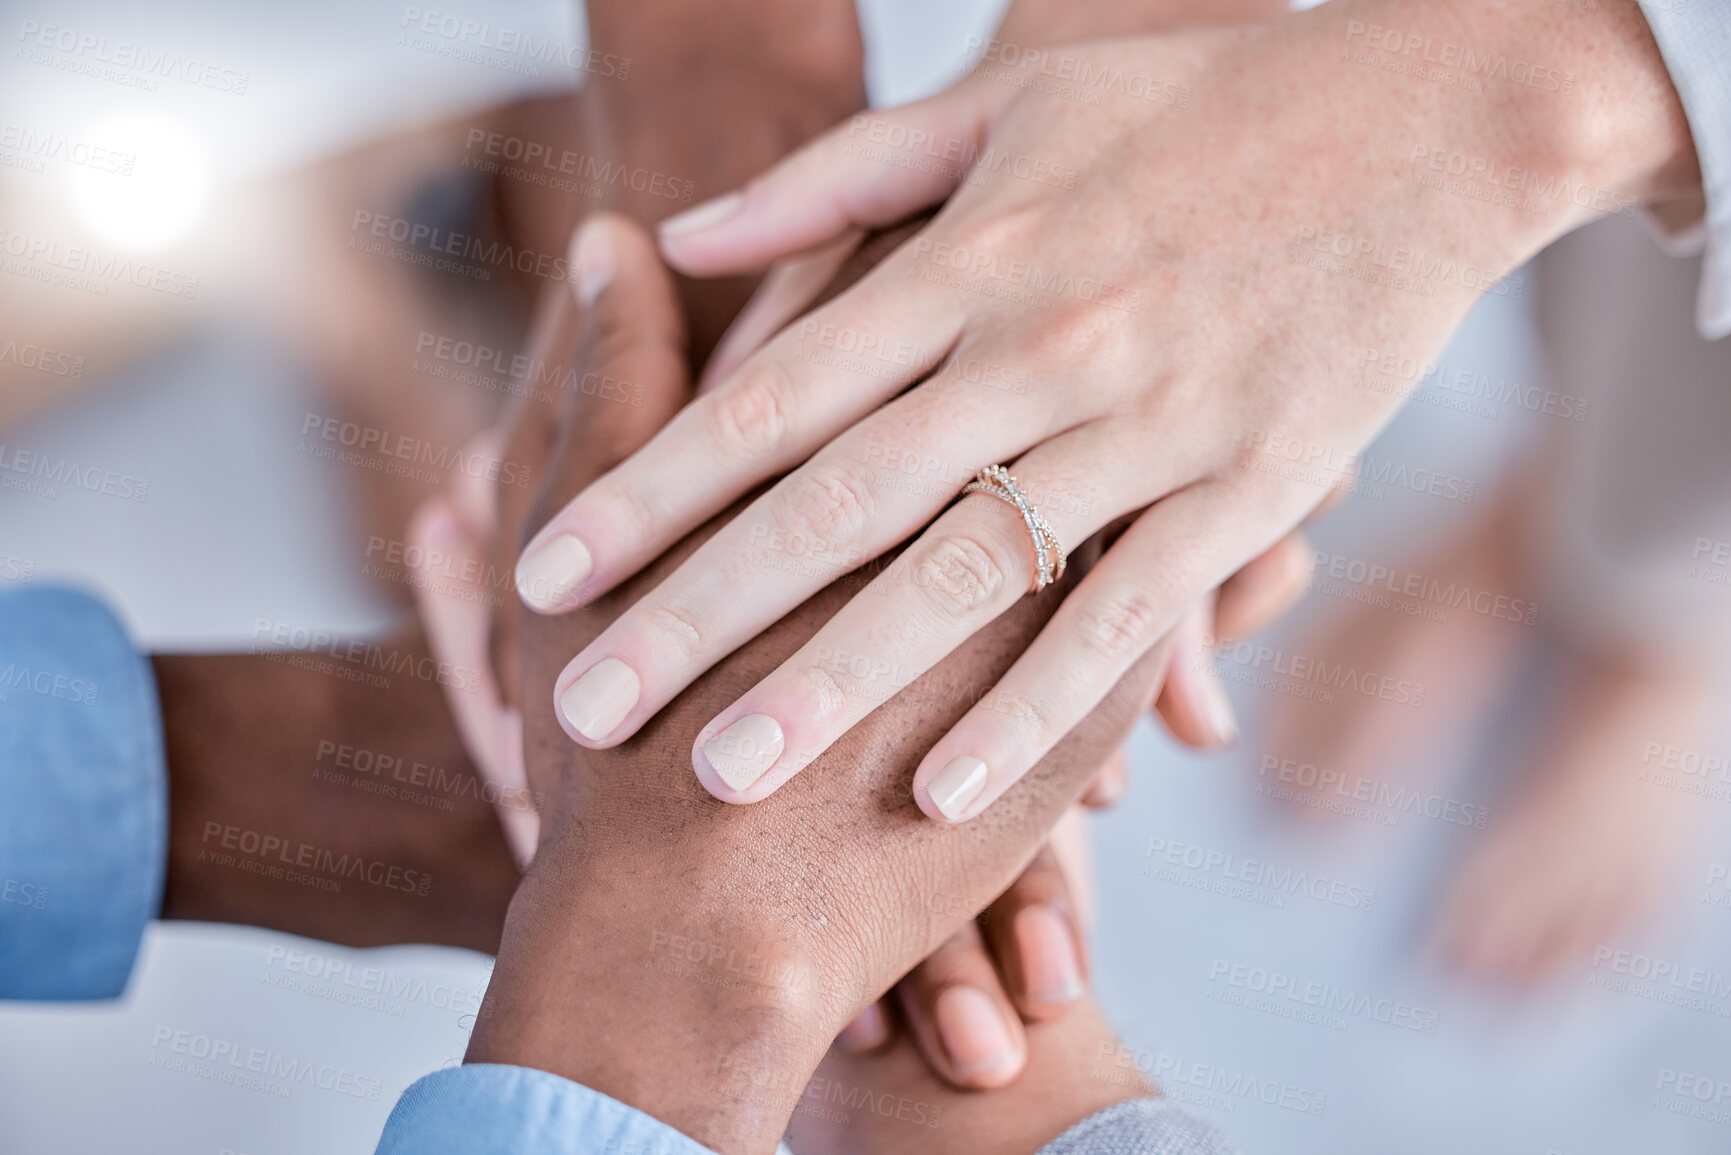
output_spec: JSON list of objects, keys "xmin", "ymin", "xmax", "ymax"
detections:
[{"xmin": 0, "ymin": 589, "xmax": 168, "ymax": 999}]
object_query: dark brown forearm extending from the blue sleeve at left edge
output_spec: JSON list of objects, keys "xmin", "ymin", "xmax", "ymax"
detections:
[{"xmin": 154, "ymin": 636, "xmax": 519, "ymax": 952}]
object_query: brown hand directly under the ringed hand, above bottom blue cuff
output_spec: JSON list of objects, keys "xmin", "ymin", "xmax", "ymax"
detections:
[{"xmin": 467, "ymin": 222, "xmax": 1163, "ymax": 1152}]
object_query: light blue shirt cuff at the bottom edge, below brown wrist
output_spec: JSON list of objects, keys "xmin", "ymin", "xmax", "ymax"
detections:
[{"xmin": 377, "ymin": 1063, "xmax": 711, "ymax": 1155}]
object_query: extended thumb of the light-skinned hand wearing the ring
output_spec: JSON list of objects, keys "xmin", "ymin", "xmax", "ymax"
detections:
[{"xmin": 660, "ymin": 80, "xmax": 1014, "ymax": 277}]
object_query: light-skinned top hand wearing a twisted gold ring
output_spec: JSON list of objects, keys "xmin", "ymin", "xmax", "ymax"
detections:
[{"xmin": 505, "ymin": 0, "xmax": 1696, "ymax": 821}]
